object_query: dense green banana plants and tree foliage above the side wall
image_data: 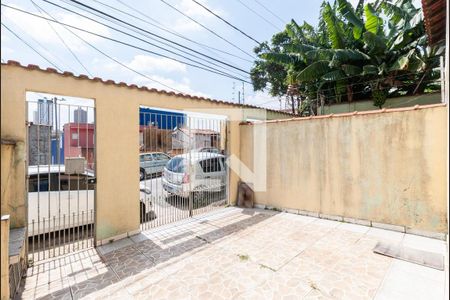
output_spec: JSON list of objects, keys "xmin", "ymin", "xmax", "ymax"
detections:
[{"xmin": 251, "ymin": 0, "xmax": 444, "ymax": 114}]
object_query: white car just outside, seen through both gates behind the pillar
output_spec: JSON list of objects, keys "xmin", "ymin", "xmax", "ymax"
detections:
[{"xmin": 28, "ymin": 165, "xmax": 152, "ymax": 236}]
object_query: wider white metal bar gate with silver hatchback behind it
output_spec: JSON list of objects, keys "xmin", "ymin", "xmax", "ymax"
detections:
[{"xmin": 139, "ymin": 107, "xmax": 229, "ymax": 230}]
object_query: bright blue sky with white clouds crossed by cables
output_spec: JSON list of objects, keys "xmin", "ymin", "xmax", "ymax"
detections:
[{"xmin": 1, "ymin": 0, "xmax": 321, "ymax": 108}]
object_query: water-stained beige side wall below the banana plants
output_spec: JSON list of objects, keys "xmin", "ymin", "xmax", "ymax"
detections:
[{"xmin": 241, "ymin": 104, "xmax": 448, "ymax": 233}]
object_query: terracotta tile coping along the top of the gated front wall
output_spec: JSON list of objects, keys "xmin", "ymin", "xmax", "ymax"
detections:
[{"xmin": 1, "ymin": 60, "xmax": 293, "ymax": 116}]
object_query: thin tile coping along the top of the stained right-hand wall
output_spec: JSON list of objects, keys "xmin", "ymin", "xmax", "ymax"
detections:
[{"xmin": 243, "ymin": 103, "xmax": 447, "ymax": 125}]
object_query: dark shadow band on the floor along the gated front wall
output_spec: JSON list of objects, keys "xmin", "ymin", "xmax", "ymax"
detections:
[{"xmin": 16, "ymin": 210, "xmax": 274, "ymax": 299}]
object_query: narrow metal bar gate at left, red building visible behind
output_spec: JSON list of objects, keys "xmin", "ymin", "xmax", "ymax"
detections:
[{"xmin": 26, "ymin": 97, "xmax": 96, "ymax": 261}]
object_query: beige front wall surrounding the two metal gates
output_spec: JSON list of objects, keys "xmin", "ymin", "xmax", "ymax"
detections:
[{"xmin": 1, "ymin": 62, "xmax": 288, "ymax": 244}]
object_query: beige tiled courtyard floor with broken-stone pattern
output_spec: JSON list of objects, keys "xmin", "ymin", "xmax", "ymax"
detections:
[{"xmin": 18, "ymin": 207, "xmax": 448, "ymax": 300}]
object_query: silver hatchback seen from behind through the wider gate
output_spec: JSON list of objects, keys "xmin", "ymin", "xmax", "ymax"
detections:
[{"xmin": 162, "ymin": 152, "xmax": 227, "ymax": 198}]
